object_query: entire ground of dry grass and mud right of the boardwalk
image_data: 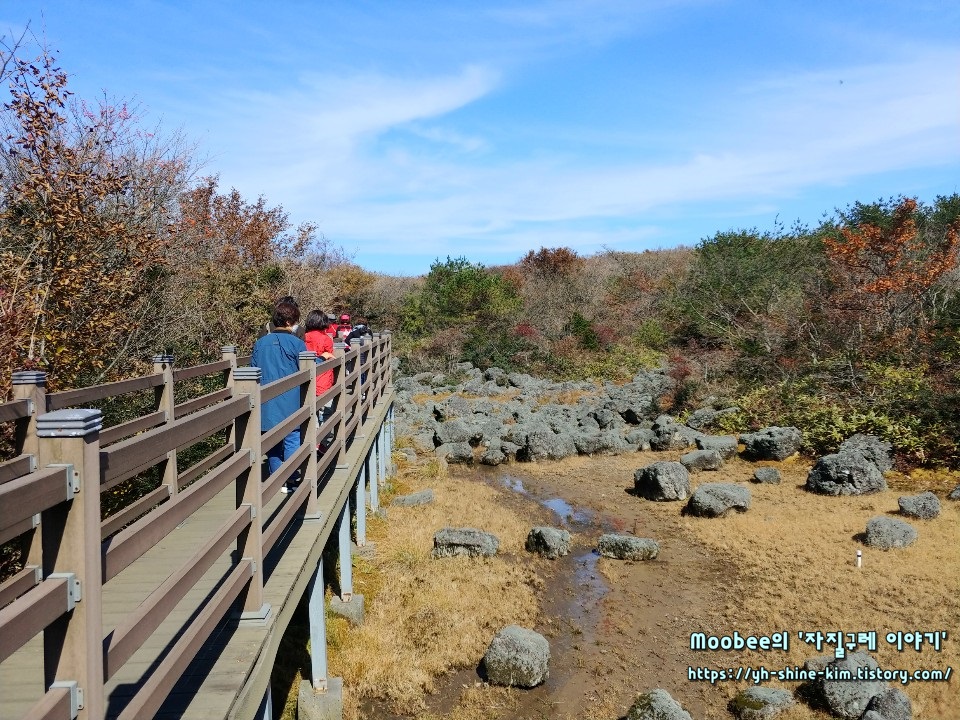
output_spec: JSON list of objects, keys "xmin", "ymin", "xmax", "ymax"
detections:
[{"xmin": 282, "ymin": 453, "xmax": 960, "ymax": 720}]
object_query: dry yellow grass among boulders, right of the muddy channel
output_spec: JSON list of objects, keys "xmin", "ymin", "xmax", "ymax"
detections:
[{"xmin": 510, "ymin": 452, "xmax": 960, "ymax": 720}]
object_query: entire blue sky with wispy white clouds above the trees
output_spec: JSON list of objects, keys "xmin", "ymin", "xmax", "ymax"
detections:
[{"xmin": 0, "ymin": 0, "xmax": 960, "ymax": 275}]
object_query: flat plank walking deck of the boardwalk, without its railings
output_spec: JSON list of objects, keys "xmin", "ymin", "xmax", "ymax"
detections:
[{"xmin": 0, "ymin": 395, "xmax": 392, "ymax": 720}]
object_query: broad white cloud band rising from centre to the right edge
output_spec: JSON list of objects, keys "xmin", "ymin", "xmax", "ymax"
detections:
[{"xmin": 298, "ymin": 45, "xmax": 960, "ymax": 270}]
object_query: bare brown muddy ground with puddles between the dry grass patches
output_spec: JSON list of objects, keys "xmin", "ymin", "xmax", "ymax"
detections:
[{"xmin": 402, "ymin": 456, "xmax": 737, "ymax": 719}]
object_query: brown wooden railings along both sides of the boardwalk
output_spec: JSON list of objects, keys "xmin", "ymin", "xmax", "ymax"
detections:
[{"xmin": 0, "ymin": 333, "xmax": 392, "ymax": 719}]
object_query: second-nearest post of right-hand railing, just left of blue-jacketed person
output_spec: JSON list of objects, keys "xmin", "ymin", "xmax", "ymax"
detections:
[{"xmin": 233, "ymin": 367, "xmax": 270, "ymax": 625}]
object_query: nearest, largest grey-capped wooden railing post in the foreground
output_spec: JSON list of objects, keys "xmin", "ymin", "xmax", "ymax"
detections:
[{"xmin": 37, "ymin": 409, "xmax": 105, "ymax": 720}]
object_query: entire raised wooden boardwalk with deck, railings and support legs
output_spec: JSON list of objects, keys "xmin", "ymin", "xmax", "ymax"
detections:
[{"xmin": 0, "ymin": 333, "xmax": 393, "ymax": 720}]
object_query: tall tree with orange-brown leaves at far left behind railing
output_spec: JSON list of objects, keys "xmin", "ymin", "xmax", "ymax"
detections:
[{"xmin": 0, "ymin": 55, "xmax": 186, "ymax": 387}]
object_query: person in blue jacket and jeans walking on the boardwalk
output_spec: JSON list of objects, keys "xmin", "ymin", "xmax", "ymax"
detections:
[{"xmin": 250, "ymin": 302, "xmax": 307, "ymax": 492}]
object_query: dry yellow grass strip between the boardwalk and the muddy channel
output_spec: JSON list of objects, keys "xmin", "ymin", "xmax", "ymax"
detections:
[{"xmin": 328, "ymin": 456, "xmax": 541, "ymax": 720}]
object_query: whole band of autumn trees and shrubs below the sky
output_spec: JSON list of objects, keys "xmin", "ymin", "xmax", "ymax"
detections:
[{"xmin": 0, "ymin": 49, "xmax": 960, "ymax": 466}]
